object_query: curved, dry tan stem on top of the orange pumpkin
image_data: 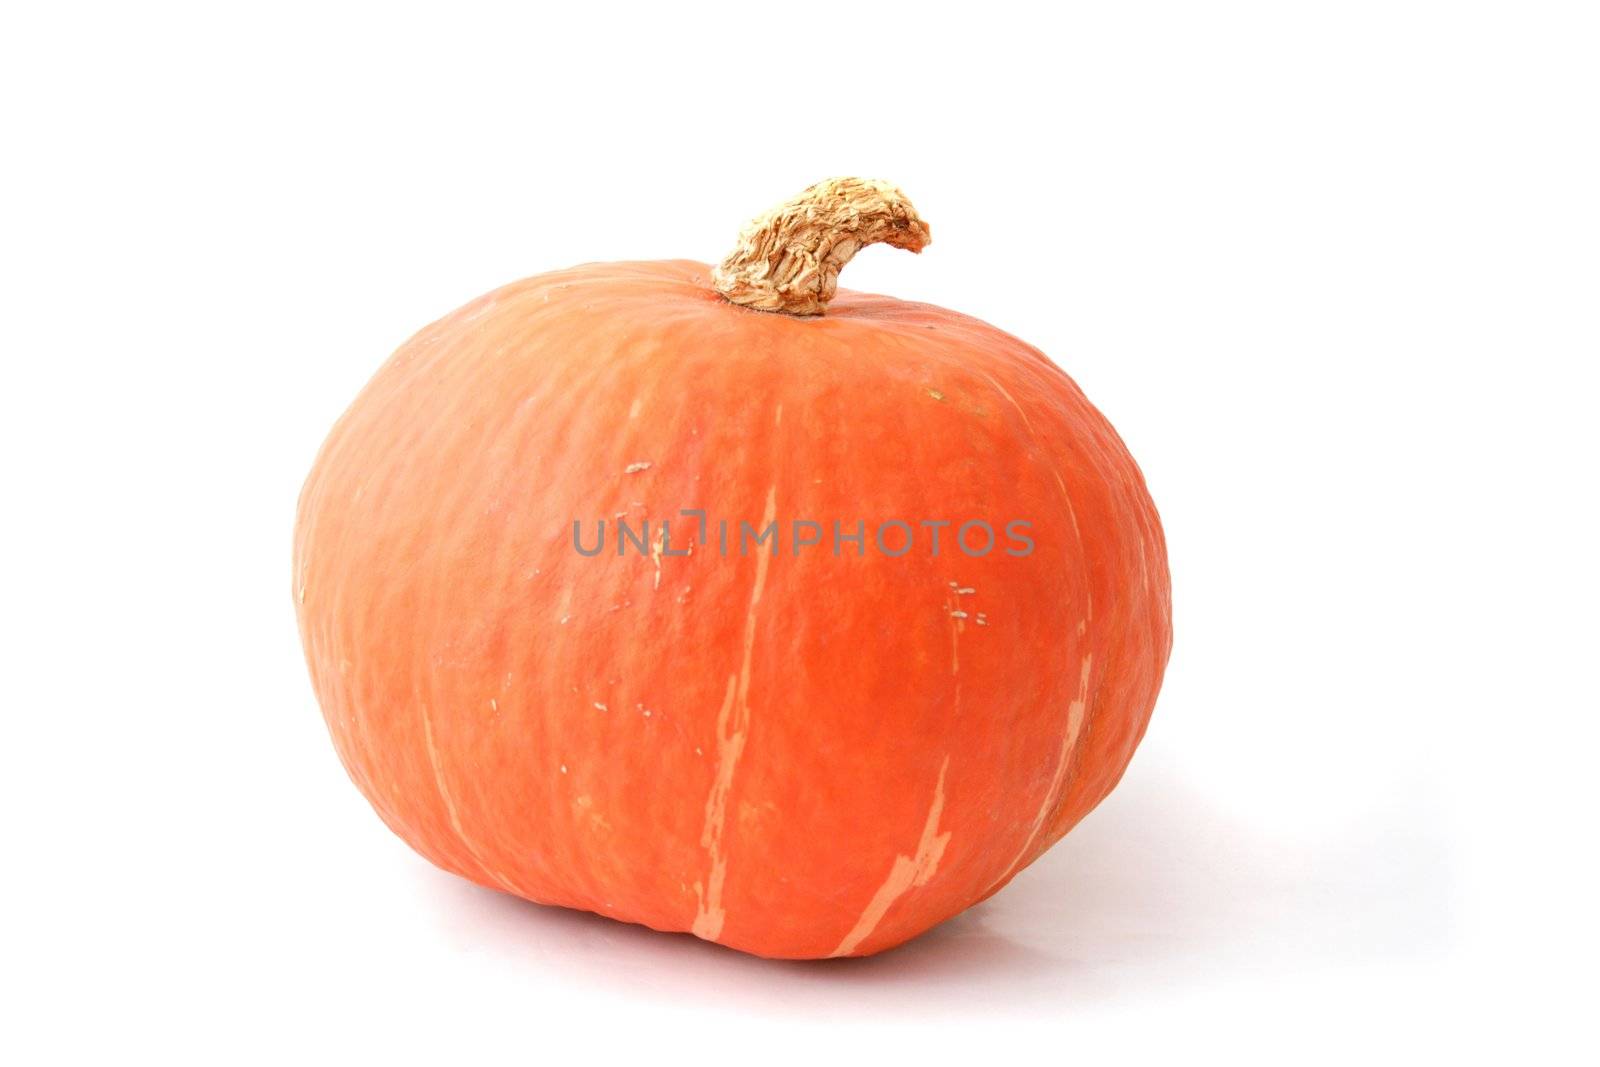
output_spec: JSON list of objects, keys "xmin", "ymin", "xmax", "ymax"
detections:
[{"xmin": 710, "ymin": 178, "xmax": 931, "ymax": 315}]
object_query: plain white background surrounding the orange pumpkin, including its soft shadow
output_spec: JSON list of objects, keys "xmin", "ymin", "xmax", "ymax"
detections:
[{"xmin": 0, "ymin": 2, "xmax": 1600, "ymax": 1062}]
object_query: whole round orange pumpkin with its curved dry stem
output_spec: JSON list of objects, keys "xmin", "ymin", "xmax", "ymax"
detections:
[{"xmin": 293, "ymin": 179, "xmax": 1171, "ymax": 958}]
